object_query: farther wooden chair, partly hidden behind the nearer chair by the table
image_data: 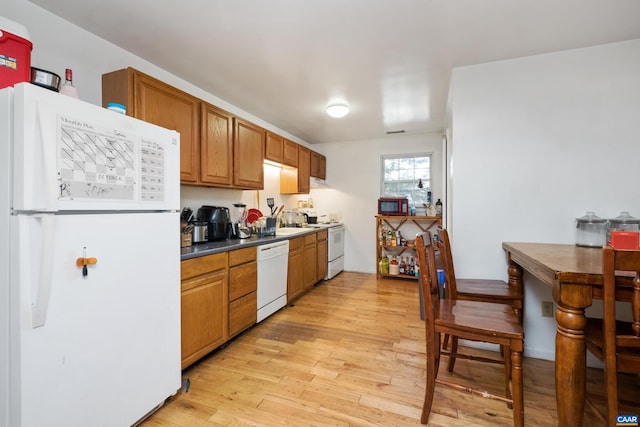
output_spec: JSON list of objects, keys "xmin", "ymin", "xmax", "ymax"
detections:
[{"xmin": 436, "ymin": 226, "xmax": 523, "ymax": 372}]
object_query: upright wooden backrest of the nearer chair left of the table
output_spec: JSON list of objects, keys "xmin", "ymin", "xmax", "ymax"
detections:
[{"xmin": 416, "ymin": 232, "xmax": 440, "ymax": 356}]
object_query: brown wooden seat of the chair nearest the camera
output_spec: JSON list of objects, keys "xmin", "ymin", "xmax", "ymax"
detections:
[{"xmin": 435, "ymin": 300, "xmax": 524, "ymax": 344}]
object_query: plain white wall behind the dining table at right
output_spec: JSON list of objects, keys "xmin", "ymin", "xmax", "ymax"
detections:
[{"xmin": 451, "ymin": 40, "xmax": 640, "ymax": 359}]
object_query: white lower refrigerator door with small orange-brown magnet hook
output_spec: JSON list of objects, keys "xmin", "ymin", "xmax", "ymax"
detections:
[{"xmin": 9, "ymin": 212, "xmax": 181, "ymax": 427}]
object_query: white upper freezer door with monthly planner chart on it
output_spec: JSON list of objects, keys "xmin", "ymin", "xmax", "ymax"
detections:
[{"xmin": 10, "ymin": 83, "xmax": 180, "ymax": 212}]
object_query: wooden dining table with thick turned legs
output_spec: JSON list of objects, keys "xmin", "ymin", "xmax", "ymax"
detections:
[{"xmin": 502, "ymin": 242, "xmax": 632, "ymax": 427}]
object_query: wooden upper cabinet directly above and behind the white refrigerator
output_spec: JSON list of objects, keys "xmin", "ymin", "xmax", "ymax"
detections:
[{"xmin": 102, "ymin": 68, "xmax": 200, "ymax": 183}]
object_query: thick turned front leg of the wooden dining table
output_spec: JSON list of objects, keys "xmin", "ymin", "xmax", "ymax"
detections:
[{"xmin": 553, "ymin": 284, "xmax": 591, "ymax": 427}]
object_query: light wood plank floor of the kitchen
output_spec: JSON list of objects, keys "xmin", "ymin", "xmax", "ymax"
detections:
[{"xmin": 143, "ymin": 272, "xmax": 640, "ymax": 427}]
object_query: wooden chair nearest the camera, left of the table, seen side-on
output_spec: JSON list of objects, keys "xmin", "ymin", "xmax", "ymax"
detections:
[{"xmin": 416, "ymin": 233, "xmax": 524, "ymax": 427}]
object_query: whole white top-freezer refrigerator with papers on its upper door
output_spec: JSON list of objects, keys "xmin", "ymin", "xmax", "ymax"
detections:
[{"xmin": 0, "ymin": 83, "xmax": 181, "ymax": 427}]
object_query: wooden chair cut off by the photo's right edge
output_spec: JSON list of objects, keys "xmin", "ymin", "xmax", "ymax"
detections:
[{"xmin": 585, "ymin": 246, "xmax": 640, "ymax": 426}]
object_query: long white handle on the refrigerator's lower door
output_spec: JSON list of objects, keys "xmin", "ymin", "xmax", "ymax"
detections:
[{"xmin": 31, "ymin": 214, "xmax": 56, "ymax": 329}]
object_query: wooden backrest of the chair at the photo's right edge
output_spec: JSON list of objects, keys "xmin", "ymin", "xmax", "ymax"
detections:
[{"xmin": 602, "ymin": 246, "xmax": 640, "ymax": 354}]
